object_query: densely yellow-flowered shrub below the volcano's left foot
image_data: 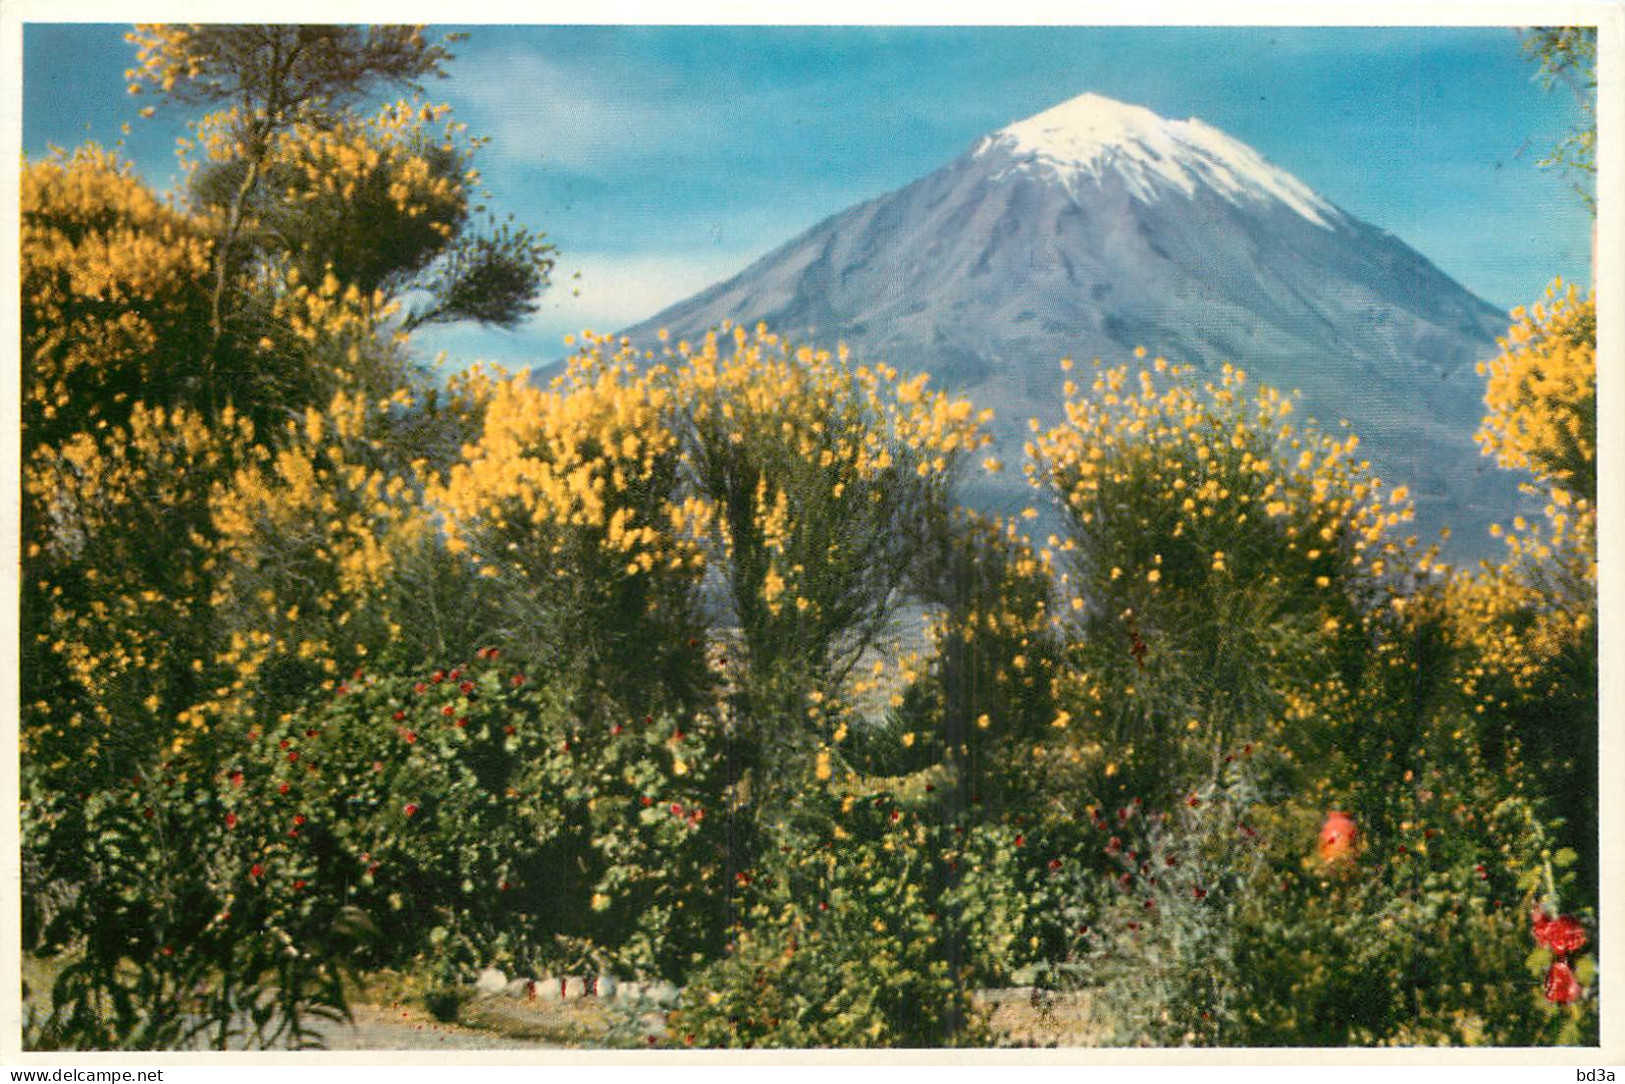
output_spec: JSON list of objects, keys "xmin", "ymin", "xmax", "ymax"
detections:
[{"xmin": 427, "ymin": 340, "xmax": 710, "ymax": 710}]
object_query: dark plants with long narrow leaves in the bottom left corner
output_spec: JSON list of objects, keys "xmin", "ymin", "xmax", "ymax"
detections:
[{"xmin": 23, "ymin": 761, "xmax": 352, "ymax": 1050}]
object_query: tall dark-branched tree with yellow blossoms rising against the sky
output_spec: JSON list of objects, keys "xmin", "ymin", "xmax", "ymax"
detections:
[{"xmin": 127, "ymin": 24, "xmax": 553, "ymax": 416}]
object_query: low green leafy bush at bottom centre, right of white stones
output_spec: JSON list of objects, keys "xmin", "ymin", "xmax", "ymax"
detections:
[{"xmin": 670, "ymin": 788, "xmax": 982, "ymax": 1048}]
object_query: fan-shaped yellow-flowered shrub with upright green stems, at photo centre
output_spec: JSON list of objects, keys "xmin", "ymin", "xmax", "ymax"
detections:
[{"xmin": 665, "ymin": 325, "xmax": 991, "ymax": 728}]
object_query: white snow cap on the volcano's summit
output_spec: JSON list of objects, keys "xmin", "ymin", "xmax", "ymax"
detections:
[{"xmin": 975, "ymin": 94, "xmax": 1342, "ymax": 229}]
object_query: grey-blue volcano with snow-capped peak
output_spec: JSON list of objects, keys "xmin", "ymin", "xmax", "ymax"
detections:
[{"xmin": 626, "ymin": 94, "xmax": 1518, "ymax": 557}]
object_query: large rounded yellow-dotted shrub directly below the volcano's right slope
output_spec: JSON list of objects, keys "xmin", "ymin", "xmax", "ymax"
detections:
[{"xmin": 1029, "ymin": 359, "xmax": 1411, "ymax": 787}]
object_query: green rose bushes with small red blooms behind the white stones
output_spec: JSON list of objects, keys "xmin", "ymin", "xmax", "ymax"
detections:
[{"xmin": 242, "ymin": 648, "xmax": 720, "ymax": 975}]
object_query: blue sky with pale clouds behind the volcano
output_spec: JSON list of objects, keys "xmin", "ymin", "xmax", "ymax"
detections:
[{"xmin": 23, "ymin": 24, "xmax": 1591, "ymax": 362}]
